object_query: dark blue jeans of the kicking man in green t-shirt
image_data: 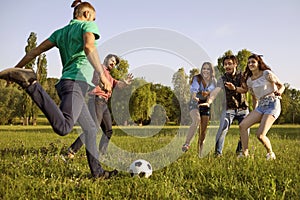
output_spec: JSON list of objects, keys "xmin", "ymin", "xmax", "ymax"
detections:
[{"xmin": 26, "ymin": 79, "xmax": 104, "ymax": 177}]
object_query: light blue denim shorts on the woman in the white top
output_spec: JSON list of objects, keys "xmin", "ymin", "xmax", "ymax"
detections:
[{"xmin": 255, "ymin": 96, "xmax": 281, "ymax": 119}]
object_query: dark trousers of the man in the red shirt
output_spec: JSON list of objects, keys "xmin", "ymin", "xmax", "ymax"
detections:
[{"xmin": 70, "ymin": 96, "xmax": 113, "ymax": 154}]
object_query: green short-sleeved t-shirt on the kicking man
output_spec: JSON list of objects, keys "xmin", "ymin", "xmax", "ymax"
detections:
[{"xmin": 48, "ymin": 19, "xmax": 100, "ymax": 86}]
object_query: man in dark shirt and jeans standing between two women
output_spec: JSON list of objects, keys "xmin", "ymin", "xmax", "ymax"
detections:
[{"xmin": 200, "ymin": 55, "xmax": 249, "ymax": 157}]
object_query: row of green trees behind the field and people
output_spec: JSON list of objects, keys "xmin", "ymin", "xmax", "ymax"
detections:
[{"xmin": 0, "ymin": 32, "xmax": 300, "ymax": 125}]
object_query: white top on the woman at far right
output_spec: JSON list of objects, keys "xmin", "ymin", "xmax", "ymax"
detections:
[{"xmin": 247, "ymin": 70, "xmax": 277, "ymax": 99}]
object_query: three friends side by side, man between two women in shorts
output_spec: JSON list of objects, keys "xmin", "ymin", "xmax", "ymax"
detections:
[{"xmin": 182, "ymin": 54, "xmax": 285, "ymax": 160}]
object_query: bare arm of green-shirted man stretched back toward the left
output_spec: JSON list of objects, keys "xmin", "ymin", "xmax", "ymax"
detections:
[{"xmin": 15, "ymin": 39, "xmax": 55, "ymax": 68}]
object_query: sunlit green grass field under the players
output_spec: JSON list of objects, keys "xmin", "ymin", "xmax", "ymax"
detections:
[{"xmin": 0, "ymin": 125, "xmax": 300, "ymax": 199}]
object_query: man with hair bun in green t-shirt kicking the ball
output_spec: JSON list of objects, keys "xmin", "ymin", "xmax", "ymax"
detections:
[{"xmin": 0, "ymin": 1, "xmax": 117, "ymax": 178}]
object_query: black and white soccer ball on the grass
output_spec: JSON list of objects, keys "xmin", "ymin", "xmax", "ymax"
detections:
[{"xmin": 129, "ymin": 159, "xmax": 152, "ymax": 178}]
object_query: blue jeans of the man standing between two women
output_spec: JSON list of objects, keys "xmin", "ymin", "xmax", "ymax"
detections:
[{"xmin": 215, "ymin": 109, "xmax": 249, "ymax": 155}]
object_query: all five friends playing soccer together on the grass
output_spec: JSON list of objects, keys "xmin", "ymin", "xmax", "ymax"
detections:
[{"xmin": 0, "ymin": 0, "xmax": 284, "ymax": 179}]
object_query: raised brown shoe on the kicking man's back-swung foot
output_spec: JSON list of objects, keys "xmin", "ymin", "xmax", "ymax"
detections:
[{"xmin": 0, "ymin": 68, "xmax": 37, "ymax": 89}]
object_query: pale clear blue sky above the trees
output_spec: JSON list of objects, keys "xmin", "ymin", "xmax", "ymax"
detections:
[{"xmin": 0, "ymin": 0, "xmax": 300, "ymax": 90}]
